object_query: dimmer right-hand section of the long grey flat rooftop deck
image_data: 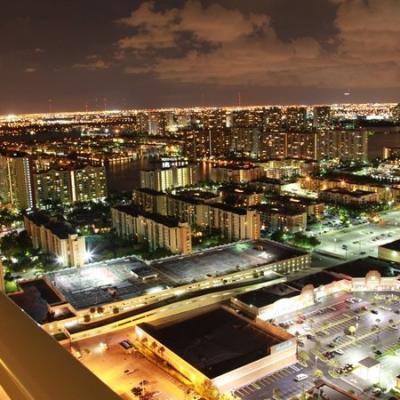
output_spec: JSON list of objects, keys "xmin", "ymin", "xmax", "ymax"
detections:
[{"xmin": 152, "ymin": 240, "xmax": 307, "ymax": 283}]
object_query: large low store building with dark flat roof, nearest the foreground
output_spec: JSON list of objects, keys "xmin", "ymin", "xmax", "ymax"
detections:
[{"xmin": 135, "ymin": 306, "xmax": 297, "ymax": 394}]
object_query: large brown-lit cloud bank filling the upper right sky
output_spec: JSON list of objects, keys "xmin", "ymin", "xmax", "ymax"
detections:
[{"xmin": 118, "ymin": 0, "xmax": 400, "ymax": 88}]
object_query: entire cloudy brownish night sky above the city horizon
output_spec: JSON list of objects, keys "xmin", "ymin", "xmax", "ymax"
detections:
[{"xmin": 0, "ymin": 0, "xmax": 400, "ymax": 114}]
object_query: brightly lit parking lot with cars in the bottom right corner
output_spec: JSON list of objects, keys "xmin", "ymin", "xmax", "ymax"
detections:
[{"xmin": 235, "ymin": 293, "xmax": 400, "ymax": 400}]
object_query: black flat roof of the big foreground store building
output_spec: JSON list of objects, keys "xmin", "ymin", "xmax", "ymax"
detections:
[{"xmin": 139, "ymin": 308, "xmax": 280, "ymax": 379}]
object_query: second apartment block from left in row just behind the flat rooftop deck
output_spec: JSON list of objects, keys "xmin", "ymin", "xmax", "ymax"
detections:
[{"xmin": 111, "ymin": 205, "xmax": 192, "ymax": 254}]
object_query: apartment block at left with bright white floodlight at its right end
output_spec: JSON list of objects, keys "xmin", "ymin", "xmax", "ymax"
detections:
[{"xmin": 24, "ymin": 213, "xmax": 86, "ymax": 267}]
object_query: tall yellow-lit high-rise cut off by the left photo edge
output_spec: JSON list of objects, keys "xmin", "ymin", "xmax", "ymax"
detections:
[{"xmin": 0, "ymin": 153, "xmax": 35, "ymax": 210}]
